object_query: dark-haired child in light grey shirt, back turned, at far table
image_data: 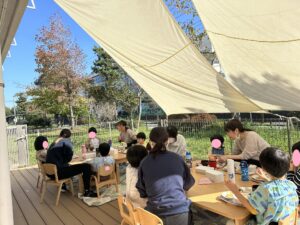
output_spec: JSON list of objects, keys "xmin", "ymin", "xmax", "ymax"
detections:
[{"xmin": 91, "ymin": 143, "xmax": 115, "ymax": 173}]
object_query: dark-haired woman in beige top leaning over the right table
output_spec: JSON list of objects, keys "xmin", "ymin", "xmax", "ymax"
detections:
[{"xmin": 220, "ymin": 119, "xmax": 270, "ymax": 166}]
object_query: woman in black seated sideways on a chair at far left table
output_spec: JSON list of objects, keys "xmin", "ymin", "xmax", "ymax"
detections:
[{"xmin": 46, "ymin": 129, "xmax": 94, "ymax": 197}]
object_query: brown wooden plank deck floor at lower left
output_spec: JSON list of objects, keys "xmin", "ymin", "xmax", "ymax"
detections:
[{"xmin": 11, "ymin": 168, "xmax": 121, "ymax": 225}]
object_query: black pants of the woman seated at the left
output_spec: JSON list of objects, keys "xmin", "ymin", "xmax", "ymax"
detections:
[{"xmin": 57, "ymin": 163, "xmax": 91, "ymax": 190}]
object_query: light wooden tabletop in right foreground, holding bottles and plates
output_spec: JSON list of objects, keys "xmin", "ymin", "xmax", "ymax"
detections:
[{"xmin": 187, "ymin": 167, "xmax": 256, "ymax": 225}]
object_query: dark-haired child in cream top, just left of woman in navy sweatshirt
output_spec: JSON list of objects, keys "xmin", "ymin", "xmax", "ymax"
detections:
[{"xmin": 126, "ymin": 145, "xmax": 148, "ymax": 208}]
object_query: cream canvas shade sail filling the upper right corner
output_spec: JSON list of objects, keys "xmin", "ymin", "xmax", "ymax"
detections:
[{"xmin": 193, "ymin": 0, "xmax": 300, "ymax": 110}]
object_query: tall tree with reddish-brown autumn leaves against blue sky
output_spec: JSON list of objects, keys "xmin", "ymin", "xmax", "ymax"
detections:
[{"xmin": 27, "ymin": 15, "xmax": 87, "ymax": 128}]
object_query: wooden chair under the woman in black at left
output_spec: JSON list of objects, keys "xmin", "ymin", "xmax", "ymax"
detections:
[{"xmin": 41, "ymin": 163, "xmax": 74, "ymax": 206}]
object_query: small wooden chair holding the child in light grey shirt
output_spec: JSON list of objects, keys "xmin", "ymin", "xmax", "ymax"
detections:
[{"xmin": 91, "ymin": 164, "xmax": 119, "ymax": 198}]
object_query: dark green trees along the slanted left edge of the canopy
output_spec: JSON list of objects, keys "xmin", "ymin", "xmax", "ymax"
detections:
[{"xmin": 89, "ymin": 47, "xmax": 142, "ymax": 118}]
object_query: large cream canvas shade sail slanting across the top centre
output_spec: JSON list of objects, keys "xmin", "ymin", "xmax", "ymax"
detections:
[{"xmin": 56, "ymin": 0, "xmax": 260, "ymax": 115}]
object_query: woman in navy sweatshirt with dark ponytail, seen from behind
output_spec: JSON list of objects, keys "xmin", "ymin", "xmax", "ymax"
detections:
[{"xmin": 136, "ymin": 127, "xmax": 195, "ymax": 225}]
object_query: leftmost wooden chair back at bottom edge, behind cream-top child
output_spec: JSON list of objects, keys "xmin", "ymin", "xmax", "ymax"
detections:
[{"xmin": 118, "ymin": 195, "xmax": 135, "ymax": 225}]
